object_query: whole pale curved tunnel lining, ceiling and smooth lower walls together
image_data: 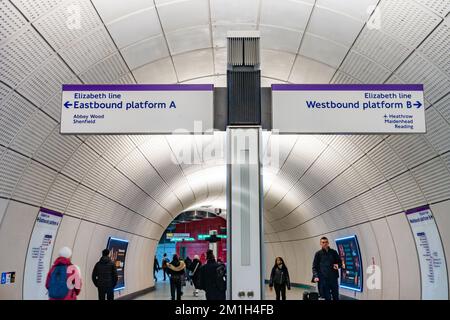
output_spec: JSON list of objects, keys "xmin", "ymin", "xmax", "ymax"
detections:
[{"xmin": 0, "ymin": 0, "xmax": 450, "ymax": 299}]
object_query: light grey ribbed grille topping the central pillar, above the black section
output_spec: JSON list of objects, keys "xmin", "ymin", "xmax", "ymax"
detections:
[{"xmin": 227, "ymin": 37, "xmax": 260, "ymax": 66}]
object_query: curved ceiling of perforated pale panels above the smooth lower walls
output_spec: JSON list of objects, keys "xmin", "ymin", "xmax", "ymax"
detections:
[{"xmin": 0, "ymin": 0, "xmax": 450, "ymax": 242}]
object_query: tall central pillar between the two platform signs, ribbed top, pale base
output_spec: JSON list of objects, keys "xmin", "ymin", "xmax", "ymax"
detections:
[{"xmin": 227, "ymin": 31, "xmax": 264, "ymax": 300}]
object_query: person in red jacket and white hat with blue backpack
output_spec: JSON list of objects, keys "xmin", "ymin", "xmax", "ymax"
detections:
[{"xmin": 45, "ymin": 247, "xmax": 81, "ymax": 300}]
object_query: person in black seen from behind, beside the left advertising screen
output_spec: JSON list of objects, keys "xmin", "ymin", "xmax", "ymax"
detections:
[{"xmin": 92, "ymin": 249, "xmax": 119, "ymax": 300}]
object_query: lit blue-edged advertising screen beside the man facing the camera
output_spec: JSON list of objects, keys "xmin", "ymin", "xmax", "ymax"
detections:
[{"xmin": 336, "ymin": 236, "xmax": 363, "ymax": 292}]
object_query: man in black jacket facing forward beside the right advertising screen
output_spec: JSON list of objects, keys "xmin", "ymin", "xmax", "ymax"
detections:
[{"xmin": 312, "ymin": 237, "xmax": 342, "ymax": 300}]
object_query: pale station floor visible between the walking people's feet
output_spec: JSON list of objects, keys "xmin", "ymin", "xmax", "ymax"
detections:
[{"xmin": 136, "ymin": 278, "xmax": 304, "ymax": 300}]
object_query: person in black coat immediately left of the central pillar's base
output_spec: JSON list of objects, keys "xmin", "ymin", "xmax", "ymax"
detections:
[{"xmin": 200, "ymin": 250, "xmax": 226, "ymax": 300}]
